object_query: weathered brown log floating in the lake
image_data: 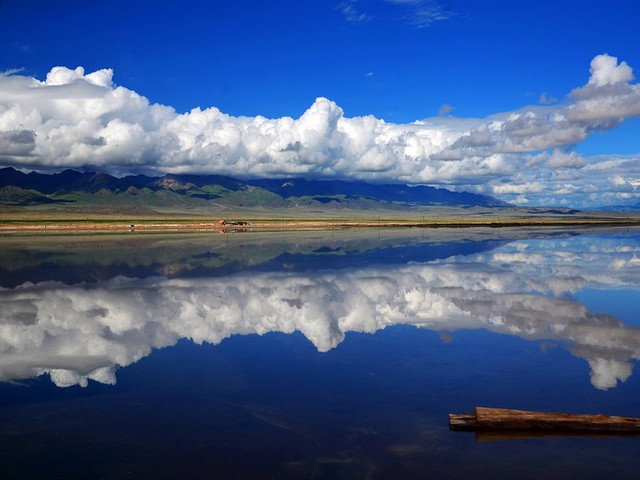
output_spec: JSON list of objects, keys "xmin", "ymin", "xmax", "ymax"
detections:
[{"xmin": 449, "ymin": 407, "xmax": 640, "ymax": 436}]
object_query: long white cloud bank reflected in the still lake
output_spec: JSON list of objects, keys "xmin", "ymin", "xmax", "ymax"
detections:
[{"xmin": 0, "ymin": 229, "xmax": 640, "ymax": 389}]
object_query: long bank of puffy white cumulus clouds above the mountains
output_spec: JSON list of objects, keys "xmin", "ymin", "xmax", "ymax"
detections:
[{"xmin": 0, "ymin": 55, "xmax": 640, "ymax": 205}]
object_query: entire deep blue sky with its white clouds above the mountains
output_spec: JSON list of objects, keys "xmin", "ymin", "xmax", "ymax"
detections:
[{"xmin": 0, "ymin": 0, "xmax": 640, "ymax": 206}]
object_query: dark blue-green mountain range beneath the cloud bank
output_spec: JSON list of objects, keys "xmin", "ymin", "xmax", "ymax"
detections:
[{"xmin": 0, "ymin": 167, "xmax": 512, "ymax": 209}]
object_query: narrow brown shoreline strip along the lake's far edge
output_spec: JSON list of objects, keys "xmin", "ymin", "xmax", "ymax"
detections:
[{"xmin": 0, "ymin": 217, "xmax": 640, "ymax": 233}]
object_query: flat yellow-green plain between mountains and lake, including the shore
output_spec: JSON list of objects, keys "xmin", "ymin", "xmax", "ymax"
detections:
[{"xmin": 0, "ymin": 203, "xmax": 640, "ymax": 233}]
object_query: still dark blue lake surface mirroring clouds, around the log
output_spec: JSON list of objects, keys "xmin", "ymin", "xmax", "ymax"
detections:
[{"xmin": 0, "ymin": 229, "xmax": 640, "ymax": 479}]
